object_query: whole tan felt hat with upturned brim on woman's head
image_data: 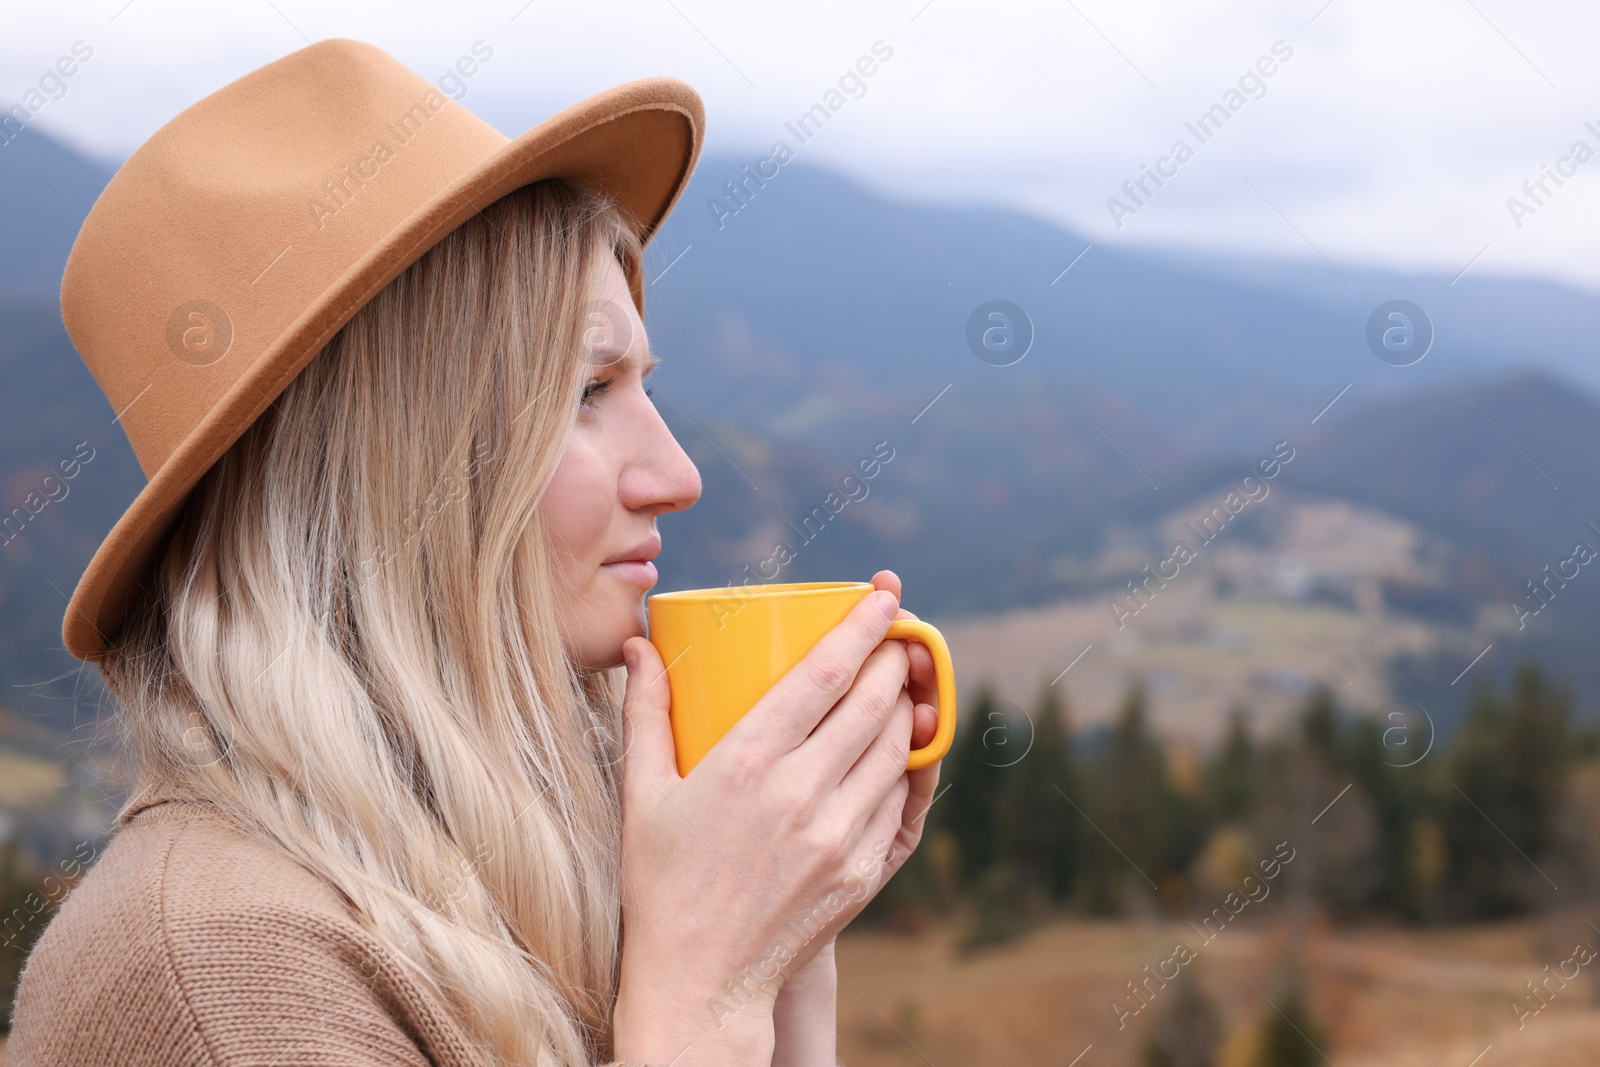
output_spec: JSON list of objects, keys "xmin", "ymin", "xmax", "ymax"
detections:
[{"xmin": 61, "ymin": 40, "xmax": 706, "ymax": 661}]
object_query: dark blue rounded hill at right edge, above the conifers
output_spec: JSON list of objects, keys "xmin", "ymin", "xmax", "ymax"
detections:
[{"xmin": 1293, "ymin": 370, "xmax": 1600, "ymax": 723}]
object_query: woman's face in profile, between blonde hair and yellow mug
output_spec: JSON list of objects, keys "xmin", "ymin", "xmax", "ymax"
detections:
[{"xmin": 539, "ymin": 256, "xmax": 701, "ymax": 669}]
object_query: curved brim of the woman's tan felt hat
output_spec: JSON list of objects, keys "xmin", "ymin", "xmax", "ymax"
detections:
[{"xmin": 62, "ymin": 77, "xmax": 706, "ymax": 661}]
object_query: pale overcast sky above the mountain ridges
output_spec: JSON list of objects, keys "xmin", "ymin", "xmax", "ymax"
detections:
[{"xmin": 0, "ymin": 0, "xmax": 1600, "ymax": 288}]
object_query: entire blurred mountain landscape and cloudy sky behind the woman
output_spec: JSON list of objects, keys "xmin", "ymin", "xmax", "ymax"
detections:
[{"xmin": 0, "ymin": 0, "xmax": 1600, "ymax": 1067}]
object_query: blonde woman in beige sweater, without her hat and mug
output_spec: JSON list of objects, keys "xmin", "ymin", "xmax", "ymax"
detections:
[{"xmin": 10, "ymin": 43, "xmax": 938, "ymax": 1067}]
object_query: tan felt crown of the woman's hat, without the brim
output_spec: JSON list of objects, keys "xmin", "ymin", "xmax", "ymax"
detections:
[{"xmin": 61, "ymin": 40, "xmax": 509, "ymax": 477}]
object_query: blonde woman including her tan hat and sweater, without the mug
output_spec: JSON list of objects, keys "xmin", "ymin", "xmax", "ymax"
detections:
[{"xmin": 10, "ymin": 42, "xmax": 938, "ymax": 1067}]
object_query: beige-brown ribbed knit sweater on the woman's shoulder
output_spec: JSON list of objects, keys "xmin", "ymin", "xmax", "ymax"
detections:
[{"xmin": 6, "ymin": 789, "xmax": 656, "ymax": 1067}]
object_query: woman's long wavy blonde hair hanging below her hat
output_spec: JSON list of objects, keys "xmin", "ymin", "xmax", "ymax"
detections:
[{"xmin": 101, "ymin": 179, "xmax": 642, "ymax": 1065}]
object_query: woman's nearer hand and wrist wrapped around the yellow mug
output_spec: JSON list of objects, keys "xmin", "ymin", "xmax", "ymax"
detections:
[{"xmin": 614, "ymin": 579, "xmax": 938, "ymax": 1067}]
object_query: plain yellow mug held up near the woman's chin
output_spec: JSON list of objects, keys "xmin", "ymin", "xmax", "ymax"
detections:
[{"xmin": 645, "ymin": 582, "xmax": 955, "ymax": 774}]
